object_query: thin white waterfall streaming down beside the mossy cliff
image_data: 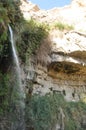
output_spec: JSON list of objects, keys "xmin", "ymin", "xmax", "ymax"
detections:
[{"xmin": 9, "ymin": 26, "xmax": 25, "ymax": 130}]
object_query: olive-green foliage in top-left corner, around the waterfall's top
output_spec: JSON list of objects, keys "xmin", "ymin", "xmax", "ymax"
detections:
[{"xmin": 0, "ymin": 0, "xmax": 23, "ymax": 57}]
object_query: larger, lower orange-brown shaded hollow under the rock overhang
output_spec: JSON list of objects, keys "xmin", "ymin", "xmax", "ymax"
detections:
[{"xmin": 48, "ymin": 61, "xmax": 86, "ymax": 77}]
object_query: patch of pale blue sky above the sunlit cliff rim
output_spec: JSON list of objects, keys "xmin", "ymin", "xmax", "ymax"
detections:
[{"xmin": 30, "ymin": 0, "xmax": 72, "ymax": 10}]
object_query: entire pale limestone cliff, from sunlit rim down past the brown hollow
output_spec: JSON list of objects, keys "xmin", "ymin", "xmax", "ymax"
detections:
[{"xmin": 20, "ymin": 0, "xmax": 86, "ymax": 101}]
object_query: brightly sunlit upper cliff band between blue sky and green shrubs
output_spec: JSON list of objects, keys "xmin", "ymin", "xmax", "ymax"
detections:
[{"xmin": 20, "ymin": 0, "xmax": 86, "ymax": 31}]
